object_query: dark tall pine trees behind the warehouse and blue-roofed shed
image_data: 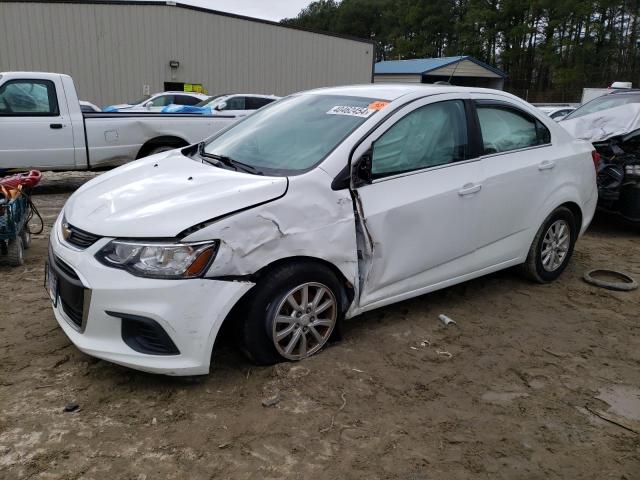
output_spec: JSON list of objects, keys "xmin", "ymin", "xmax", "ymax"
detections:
[{"xmin": 283, "ymin": 0, "xmax": 640, "ymax": 101}]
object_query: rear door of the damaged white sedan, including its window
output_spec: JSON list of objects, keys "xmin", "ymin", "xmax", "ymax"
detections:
[{"xmin": 474, "ymin": 94, "xmax": 557, "ymax": 268}]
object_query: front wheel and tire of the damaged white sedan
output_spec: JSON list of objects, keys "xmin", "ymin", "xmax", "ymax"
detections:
[{"xmin": 240, "ymin": 262, "xmax": 344, "ymax": 365}]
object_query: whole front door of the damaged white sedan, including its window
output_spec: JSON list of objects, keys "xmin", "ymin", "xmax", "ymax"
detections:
[{"xmin": 354, "ymin": 94, "xmax": 483, "ymax": 308}]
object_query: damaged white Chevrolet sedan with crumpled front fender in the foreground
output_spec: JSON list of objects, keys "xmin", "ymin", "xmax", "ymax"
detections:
[{"xmin": 47, "ymin": 85, "xmax": 597, "ymax": 375}]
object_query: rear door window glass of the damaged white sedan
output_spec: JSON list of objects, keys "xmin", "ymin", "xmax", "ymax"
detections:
[{"xmin": 477, "ymin": 105, "xmax": 551, "ymax": 154}]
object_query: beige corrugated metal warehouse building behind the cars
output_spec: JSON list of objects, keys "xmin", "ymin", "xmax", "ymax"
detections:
[{"xmin": 0, "ymin": 0, "xmax": 374, "ymax": 105}]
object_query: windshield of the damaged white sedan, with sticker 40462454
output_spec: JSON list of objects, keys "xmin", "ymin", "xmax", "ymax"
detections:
[{"xmin": 204, "ymin": 94, "xmax": 386, "ymax": 174}]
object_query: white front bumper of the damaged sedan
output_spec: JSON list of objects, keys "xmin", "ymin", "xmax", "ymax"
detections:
[{"xmin": 49, "ymin": 217, "xmax": 254, "ymax": 375}]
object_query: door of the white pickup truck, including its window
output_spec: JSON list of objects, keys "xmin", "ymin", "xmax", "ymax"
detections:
[{"xmin": 0, "ymin": 77, "xmax": 75, "ymax": 169}]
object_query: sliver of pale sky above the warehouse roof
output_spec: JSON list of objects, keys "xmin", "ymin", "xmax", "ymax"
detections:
[{"xmin": 124, "ymin": 0, "xmax": 311, "ymax": 22}]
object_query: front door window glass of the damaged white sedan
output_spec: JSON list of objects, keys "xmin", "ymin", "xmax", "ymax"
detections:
[{"xmin": 371, "ymin": 100, "xmax": 469, "ymax": 178}]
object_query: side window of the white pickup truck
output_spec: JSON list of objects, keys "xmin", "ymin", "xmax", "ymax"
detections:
[{"xmin": 0, "ymin": 80, "xmax": 60, "ymax": 117}]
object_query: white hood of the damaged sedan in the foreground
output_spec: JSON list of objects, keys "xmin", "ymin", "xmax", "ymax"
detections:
[{"xmin": 64, "ymin": 150, "xmax": 288, "ymax": 238}]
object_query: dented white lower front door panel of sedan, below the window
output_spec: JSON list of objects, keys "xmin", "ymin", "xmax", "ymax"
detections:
[{"xmin": 357, "ymin": 161, "xmax": 482, "ymax": 307}]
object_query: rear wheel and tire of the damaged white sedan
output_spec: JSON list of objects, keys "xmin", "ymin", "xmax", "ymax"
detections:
[{"xmin": 522, "ymin": 207, "xmax": 578, "ymax": 283}]
